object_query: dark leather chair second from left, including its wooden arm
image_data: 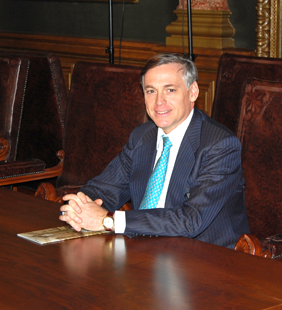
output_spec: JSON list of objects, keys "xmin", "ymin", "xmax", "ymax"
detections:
[{"xmin": 0, "ymin": 52, "xmax": 67, "ymax": 186}]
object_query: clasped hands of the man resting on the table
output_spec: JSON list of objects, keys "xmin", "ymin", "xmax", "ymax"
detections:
[{"xmin": 59, "ymin": 192, "xmax": 108, "ymax": 231}]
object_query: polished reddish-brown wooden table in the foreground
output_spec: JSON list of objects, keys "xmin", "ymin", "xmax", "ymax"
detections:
[{"xmin": 0, "ymin": 189, "xmax": 282, "ymax": 310}]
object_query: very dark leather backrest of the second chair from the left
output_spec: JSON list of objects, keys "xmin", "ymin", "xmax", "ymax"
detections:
[{"xmin": 14, "ymin": 53, "xmax": 67, "ymax": 168}]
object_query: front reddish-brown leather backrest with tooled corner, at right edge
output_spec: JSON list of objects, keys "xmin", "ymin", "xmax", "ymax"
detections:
[{"xmin": 237, "ymin": 77, "xmax": 282, "ymax": 239}]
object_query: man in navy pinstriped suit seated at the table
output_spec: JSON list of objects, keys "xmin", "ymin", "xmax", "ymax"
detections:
[{"xmin": 60, "ymin": 54, "xmax": 249, "ymax": 248}]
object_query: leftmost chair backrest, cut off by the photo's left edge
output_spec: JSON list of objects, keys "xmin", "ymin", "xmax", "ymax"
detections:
[{"xmin": 0, "ymin": 56, "xmax": 29, "ymax": 162}]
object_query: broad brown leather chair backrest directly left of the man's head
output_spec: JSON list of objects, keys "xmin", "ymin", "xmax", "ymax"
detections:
[{"xmin": 58, "ymin": 62, "xmax": 146, "ymax": 186}]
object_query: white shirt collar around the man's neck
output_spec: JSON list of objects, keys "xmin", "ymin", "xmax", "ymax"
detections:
[{"xmin": 156, "ymin": 109, "xmax": 194, "ymax": 150}]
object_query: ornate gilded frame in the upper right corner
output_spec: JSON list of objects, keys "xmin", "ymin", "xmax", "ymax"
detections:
[{"xmin": 256, "ymin": 0, "xmax": 282, "ymax": 58}]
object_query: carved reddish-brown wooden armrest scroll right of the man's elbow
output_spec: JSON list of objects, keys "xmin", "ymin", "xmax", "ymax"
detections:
[{"xmin": 235, "ymin": 234, "xmax": 271, "ymax": 258}]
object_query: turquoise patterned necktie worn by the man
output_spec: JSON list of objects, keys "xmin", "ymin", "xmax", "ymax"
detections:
[{"xmin": 139, "ymin": 136, "xmax": 172, "ymax": 209}]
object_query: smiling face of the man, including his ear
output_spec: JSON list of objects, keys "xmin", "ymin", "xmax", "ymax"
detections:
[{"xmin": 144, "ymin": 63, "xmax": 199, "ymax": 134}]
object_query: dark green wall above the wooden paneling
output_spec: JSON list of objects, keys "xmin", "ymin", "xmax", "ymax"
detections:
[{"xmin": 0, "ymin": 0, "xmax": 256, "ymax": 49}]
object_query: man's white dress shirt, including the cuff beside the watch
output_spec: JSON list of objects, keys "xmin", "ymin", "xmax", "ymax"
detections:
[{"xmin": 115, "ymin": 109, "xmax": 194, "ymax": 234}]
